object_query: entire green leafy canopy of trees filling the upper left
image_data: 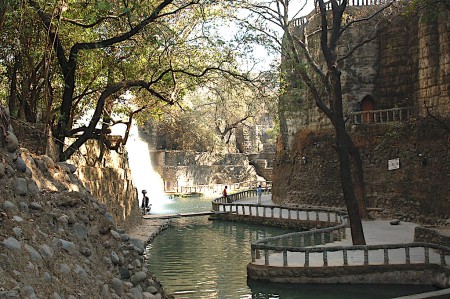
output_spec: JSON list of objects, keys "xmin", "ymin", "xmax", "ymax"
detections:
[{"xmin": 0, "ymin": 0, "xmax": 276, "ymax": 160}]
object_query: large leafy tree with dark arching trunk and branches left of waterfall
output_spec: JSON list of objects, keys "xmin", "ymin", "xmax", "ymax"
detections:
[{"xmin": 18, "ymin": 0, "xmax": 256, "ymax": 161}]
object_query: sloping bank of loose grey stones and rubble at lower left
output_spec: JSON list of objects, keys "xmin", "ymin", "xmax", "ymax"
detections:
[{"xmin": 0, "ymin": 107, "xmax": 168, "ymax": 299}]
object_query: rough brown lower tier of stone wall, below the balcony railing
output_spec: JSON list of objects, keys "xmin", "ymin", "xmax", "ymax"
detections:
[{"xmin": 272, "ymin": 119, "xmax": 450, "ymax": 224}]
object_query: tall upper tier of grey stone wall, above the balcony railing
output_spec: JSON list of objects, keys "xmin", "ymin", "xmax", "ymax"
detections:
[{"xmin": 279, "ymin": 2, "xmax": 450, "ymax": 139}]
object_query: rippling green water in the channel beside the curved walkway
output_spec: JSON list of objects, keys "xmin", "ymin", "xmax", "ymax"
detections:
[{"xmin": 146, "ymin": 198, "xmax": 433, "ymax": 299}]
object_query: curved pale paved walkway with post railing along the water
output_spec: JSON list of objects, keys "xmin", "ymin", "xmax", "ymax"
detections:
[{"xmin": 213, "ymin": 190, "xmax": 450, "ymax": 288}]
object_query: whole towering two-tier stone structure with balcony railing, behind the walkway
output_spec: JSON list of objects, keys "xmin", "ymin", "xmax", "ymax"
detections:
[{"xmin": 273, "ymin": 1, "xmax": 450, "ymax": 223}]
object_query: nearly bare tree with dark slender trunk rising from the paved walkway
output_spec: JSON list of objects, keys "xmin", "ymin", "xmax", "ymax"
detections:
[{"xmin": 241, "ymin": 0, "xmax": 400, "ymax": 244}]
